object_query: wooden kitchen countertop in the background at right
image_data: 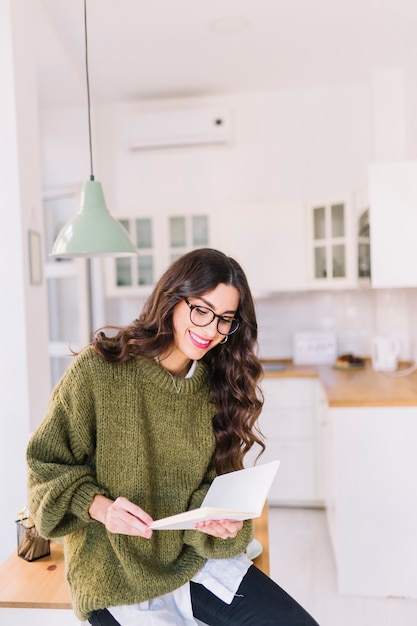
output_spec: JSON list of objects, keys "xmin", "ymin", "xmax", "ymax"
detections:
[{"xmin": 265, "ymin": 360, "xmax": 417, "ymax": 407}]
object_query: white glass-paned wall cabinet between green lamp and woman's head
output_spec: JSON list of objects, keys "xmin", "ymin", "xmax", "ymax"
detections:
[{"xmin": 104, "ymin": 211, "xmax": 215, "ymax": 297}]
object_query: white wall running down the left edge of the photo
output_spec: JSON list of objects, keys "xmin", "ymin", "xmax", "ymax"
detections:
[{"xmin": 0, "ymin": 0, "xmax": 49, "ymax": 561}]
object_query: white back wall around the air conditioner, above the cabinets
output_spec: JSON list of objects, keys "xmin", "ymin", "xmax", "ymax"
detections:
[{"xmin": 42, "ymin": 85, "xmax": 370, "ymax": 207}]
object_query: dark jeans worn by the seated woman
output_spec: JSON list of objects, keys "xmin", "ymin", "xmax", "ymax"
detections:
[{"xmin": 89, "ymin": 565, "xmax": 318, "ymax": 626}]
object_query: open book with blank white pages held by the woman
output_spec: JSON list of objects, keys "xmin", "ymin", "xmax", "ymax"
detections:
[{"xmin": 150, "ymin": 461, "xmax": 280, "ymax": 530}]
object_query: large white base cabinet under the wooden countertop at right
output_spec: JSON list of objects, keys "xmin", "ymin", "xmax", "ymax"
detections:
[{"xmin": 326, "ymin": 407, "xmax": 417, "ymax": 598}]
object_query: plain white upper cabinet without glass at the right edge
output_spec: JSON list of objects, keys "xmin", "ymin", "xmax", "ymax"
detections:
[{"xmin": 369, "ymin": 161, "xmax": 417, "ymax": 288}]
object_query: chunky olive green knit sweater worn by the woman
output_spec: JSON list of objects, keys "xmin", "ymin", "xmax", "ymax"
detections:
[{"xmin": 27, "ymin": 347, "xmax": 253, "ymax": 620}]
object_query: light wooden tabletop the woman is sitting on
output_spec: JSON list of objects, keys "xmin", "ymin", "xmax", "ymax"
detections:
[{"xmin": 0, "ymin": 504, "xmax": 269, "ymax": 609}]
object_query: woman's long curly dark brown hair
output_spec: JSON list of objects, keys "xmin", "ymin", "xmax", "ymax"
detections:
[{"xmin": 91, "ymin": 248, "xmax": 265, "ymax": 473}]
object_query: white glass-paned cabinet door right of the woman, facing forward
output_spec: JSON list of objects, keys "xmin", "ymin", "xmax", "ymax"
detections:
[{"xmin": 307, "ymin": 198, "xmax": 358, "ymax": 289}]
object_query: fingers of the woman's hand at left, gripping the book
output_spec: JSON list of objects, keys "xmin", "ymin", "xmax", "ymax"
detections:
[{"xmin": 105, "ymin": 497, "xmax": 153, "ymax": 538}]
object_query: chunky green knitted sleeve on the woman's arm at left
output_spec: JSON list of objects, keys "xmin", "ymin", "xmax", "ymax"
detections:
[{"xmin": 27, "ymin": 356, "xmax": 107, "ymax": 537}]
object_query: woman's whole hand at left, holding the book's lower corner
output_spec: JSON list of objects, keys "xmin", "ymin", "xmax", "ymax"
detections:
[{"xmin": 88, "ymin": 494, "xmax": 153, "ymax": 539}]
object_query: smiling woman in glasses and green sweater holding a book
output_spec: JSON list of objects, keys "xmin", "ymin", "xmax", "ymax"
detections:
[{"xmin": 27, "ymin": 249, "xmax": 316, "ymax": 626}]
